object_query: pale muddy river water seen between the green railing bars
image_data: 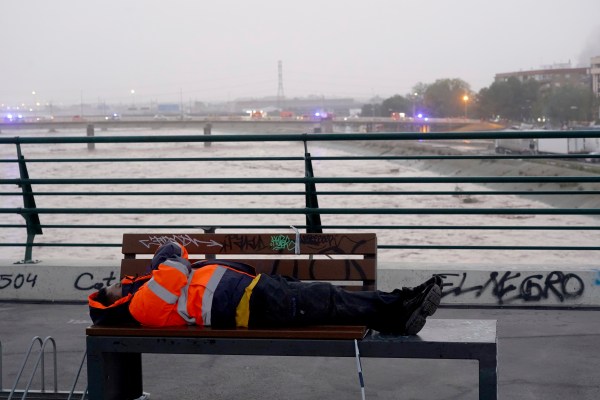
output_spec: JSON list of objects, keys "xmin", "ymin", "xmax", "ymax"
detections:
[{"xmin": 0, "ymin": 130, "xmax": 599, "ymax": 268}]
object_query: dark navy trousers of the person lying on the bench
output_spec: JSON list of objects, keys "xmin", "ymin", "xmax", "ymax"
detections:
[{"xmin": 249, "ymin": 275, "xmax": 404, "ymax": 331}]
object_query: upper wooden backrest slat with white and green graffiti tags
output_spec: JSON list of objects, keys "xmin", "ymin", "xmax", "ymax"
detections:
[{"xmin": 122, "ymin": 233, "xmax": 377, "ymax": 258}]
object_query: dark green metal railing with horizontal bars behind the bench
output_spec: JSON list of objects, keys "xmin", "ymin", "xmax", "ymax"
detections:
[{"xmin": 0, "ymin": 130, "xmax": 600, "ymax": 263}]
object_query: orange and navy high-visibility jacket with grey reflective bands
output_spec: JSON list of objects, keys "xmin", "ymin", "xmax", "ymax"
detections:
[{"xmin": 88, "ymin": 242, "xmax": 258, "ymax": 327}]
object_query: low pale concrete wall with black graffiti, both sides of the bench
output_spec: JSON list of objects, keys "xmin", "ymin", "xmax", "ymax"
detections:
[{"xmin": 0, "ymin": 260, "xmax": 600, "ymax": 307}]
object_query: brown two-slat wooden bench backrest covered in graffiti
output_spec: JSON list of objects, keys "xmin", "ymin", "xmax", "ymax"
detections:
[{"xmin": 121, "ymin": 233, "xmax": 377, "ymax": 290}]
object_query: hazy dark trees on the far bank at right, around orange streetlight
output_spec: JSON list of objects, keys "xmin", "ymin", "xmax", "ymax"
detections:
[{"xmin": 361, "ymin": 77, "xmax": 600, "ymax": 126}]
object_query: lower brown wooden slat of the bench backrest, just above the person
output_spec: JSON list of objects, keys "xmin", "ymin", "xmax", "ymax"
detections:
[{"xmin": 121, "ymin": 259, "xmax": 377, "ymax": 281}]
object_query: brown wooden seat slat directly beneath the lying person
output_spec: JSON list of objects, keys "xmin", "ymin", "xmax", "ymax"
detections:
[{"xmin": 86, "ymin": 325, "xmax": 367, "ymax": 339}]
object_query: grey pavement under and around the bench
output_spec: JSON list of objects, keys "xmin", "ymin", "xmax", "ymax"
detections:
[{"xmin": 0, "ymin": 302, "xmax": 600, "ymax": 400}]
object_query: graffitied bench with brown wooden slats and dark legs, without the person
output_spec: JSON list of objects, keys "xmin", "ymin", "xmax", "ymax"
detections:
[{"xmin": 86, "ymin": 233, "xmax": 497, "ymax": 400}]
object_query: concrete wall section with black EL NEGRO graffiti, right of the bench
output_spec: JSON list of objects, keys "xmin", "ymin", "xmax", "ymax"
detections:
[{"xmin": 377, "ymin": 263, "xmax": 600, "ymax": 307}]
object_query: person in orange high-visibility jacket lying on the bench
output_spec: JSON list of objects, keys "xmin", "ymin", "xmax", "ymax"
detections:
[{"xmin": 88, "ymin": 242, "xmax": 442, "ymax": 335}]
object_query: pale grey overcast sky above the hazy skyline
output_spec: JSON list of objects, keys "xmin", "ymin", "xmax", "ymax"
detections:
[{"xmin": 0, "ymin": 0, "xmax": 600, "ymax": 104}]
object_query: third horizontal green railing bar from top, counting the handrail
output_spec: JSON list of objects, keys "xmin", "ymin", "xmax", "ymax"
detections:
[{"xmin": 0, "ymin": 176, "xmax": 600, "ymax": 185}]
